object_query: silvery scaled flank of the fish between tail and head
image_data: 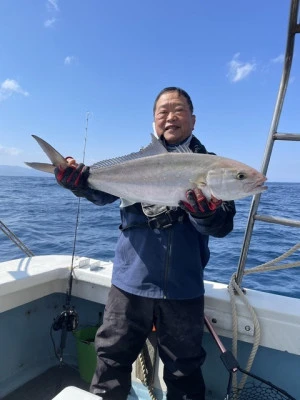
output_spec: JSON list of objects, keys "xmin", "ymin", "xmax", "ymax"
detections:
[{"xmin": 88, "ymin": 153, "xmax": 217, "ymax": 206}]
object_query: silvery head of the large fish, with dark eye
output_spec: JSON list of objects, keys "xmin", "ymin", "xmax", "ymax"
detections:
[{"xmin": 200, "ymin": 160, "xmax": 267, "ymax": 201}]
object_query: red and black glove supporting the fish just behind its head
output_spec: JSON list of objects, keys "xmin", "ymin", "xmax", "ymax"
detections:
[{"xmin": 178, "ymin": 188, "xmax": 222, "ymax": 218}]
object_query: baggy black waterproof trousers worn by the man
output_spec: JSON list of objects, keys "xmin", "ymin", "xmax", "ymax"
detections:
[{"xmin": 90, "ymin": 286, "xmax": 205, "ymax": 400}]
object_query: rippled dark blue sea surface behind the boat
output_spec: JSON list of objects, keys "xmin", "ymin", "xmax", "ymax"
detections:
[{"xmin": 0, "ymin": 176, "xmax": 300, "ymax": 298}]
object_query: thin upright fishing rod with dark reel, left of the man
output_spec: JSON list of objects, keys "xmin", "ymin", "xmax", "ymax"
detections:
[{"xmin": 50, "ymin": 112, "xmax": 90, "ymax": 365}]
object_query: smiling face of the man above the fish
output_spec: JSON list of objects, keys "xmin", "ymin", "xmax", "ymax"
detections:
[{"xmin": 154, "ymin": 91, "xmax": 196, "ymax": 144}]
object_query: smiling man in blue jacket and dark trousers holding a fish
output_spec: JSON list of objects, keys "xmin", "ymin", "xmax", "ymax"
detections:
[{"xmin": 56, "ymin": 87, "xmax": 235, "ymax": 400}]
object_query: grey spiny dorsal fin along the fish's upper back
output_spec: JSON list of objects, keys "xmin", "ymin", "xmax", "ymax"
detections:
[{"xmin": 91, "ymin": 134, "xmax": 168, "ymax": 169}]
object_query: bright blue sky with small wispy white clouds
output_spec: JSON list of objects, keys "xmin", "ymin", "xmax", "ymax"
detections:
[{"xmin": 0, "ymin": 0, "xmax": 300, "ymax": 182}]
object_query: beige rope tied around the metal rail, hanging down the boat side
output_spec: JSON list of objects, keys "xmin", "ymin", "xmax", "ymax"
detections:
[{"xmin": 228, "ymin": 243, "xmax": 300, "ymax": 389}]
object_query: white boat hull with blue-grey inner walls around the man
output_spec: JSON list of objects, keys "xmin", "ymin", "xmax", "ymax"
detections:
[{"xmin": 0, "ymin": 255, "xmax": 300, "ymax": 399}]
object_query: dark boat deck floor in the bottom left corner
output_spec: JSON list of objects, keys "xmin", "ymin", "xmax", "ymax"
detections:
[{"xmin": 2, "ymin": 365, "xmax": 89, "ymax": 400}]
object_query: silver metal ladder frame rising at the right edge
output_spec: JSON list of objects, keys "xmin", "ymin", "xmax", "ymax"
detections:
[{"xmin": 236, "ymin": 0, "xmax": 300, "ymax": 286}]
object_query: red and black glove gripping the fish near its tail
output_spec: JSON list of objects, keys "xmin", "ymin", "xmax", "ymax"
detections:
[{"xmin": 54, "ymin": 164, "xmax": 90, "ymax": 191}]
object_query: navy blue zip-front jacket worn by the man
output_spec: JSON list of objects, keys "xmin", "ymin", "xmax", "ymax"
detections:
[{"xmin": 74, "ymin": 137, "xmax": 235, "ymax": 300}]
